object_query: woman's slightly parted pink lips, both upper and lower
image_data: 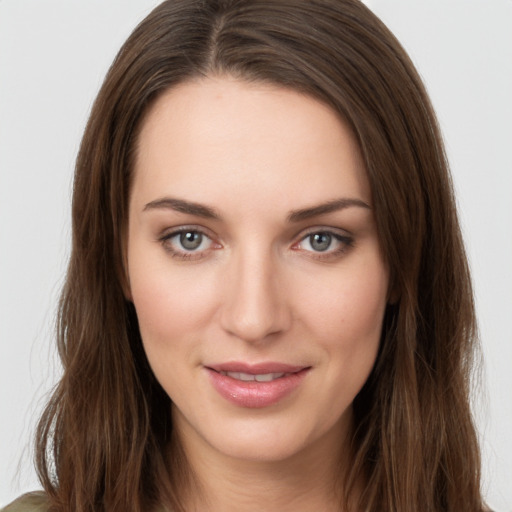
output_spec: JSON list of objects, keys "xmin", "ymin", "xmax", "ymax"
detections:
[{"xmin": 205, "ymin": 362, "xmax": 311, "ymax": 409}]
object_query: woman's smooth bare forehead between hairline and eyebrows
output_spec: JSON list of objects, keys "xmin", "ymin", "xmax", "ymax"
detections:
[{"xmin": 133, "ymin": 77, "xmax": 370, "ymax": 208}]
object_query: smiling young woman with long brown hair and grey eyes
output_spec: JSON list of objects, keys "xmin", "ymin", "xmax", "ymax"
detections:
[{"xmin": 3, "ymin": 0, "xmax": 482, "ymax": 512}]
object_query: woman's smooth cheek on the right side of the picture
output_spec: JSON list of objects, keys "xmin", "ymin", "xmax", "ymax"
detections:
[{"xmin": 296, "ymin": 254, "xmax": 388, "ymax": 402}]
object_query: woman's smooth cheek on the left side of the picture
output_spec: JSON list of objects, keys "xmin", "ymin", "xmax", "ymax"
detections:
[{"xmin": 130, "ymin": 255, "xmax": 220, "ymax": 400}]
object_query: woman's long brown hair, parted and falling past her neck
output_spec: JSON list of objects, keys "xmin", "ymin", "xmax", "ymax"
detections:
[{"xmin": 37, "ymin": 0, "xmax": 481, "ymax": 512}]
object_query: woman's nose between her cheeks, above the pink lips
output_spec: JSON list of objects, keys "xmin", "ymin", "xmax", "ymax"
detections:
[{"xmin": 221, "ymin": 246, "xmax": 291, "ymax": 342}]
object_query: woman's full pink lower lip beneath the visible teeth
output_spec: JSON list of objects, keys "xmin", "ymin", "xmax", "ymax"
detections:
[{"xmin": 207, "ymin": 368, "xmax": 309, "ymax": 409}]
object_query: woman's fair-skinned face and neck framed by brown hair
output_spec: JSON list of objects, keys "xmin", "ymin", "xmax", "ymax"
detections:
[{"xmin": 127, "ymin": 77, "xmax": 388, "ymax": 512}]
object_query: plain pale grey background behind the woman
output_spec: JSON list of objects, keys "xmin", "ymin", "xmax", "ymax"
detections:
[{"xmin": 0, "ymin": 0, "xmax": 512, "ymax": 512}]
